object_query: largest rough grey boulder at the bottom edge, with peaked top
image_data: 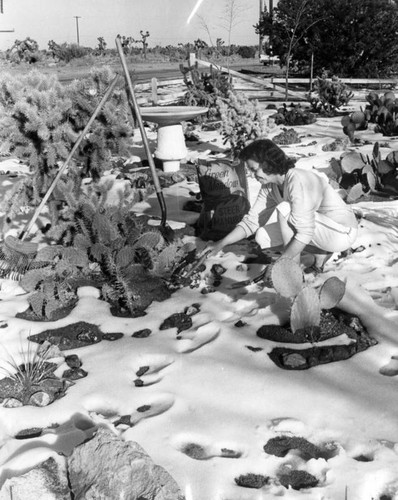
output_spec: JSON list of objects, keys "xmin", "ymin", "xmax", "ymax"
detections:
[{"xmin": 68, "ymin": 428, "xmax": 184, "ymax": 500}]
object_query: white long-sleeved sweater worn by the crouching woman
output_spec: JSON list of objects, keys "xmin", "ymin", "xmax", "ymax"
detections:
[{"xmin": 238, "ymin": 168, "xmax": 357, "ymax": 245}]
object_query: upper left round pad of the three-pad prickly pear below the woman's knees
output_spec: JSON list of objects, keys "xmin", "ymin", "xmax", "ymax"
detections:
[{"xmin": 266, "ymin": 258, "xmax": 304, "ymax": 297}]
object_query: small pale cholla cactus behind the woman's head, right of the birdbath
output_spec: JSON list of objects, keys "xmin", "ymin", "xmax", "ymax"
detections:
[{"xmin": 217, "ymin": 90, "xmax": 268, "ymax": 157}]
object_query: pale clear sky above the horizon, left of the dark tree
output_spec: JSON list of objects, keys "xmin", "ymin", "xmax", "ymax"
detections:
[{"xmin": 0, "ymin": 0, "xmax": 259, "ymax": 50}]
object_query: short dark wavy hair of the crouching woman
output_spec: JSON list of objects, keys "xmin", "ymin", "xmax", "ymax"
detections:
[{"xmin": 239, "ymin": 139, "xmax": 295, "ymax": 175}]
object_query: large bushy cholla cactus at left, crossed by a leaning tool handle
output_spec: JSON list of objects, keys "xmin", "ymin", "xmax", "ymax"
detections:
[{"xmin": 0, "ymin": 67, "xmax": 133, "ymax": 229}]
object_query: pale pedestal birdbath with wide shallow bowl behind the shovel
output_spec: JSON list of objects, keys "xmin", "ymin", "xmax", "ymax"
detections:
[{"xmin": 140, "ymin": 106, "xmax": 207, "ymax": 172}]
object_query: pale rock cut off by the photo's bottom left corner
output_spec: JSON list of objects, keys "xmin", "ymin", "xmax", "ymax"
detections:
[{"xmin": 0, "ymin": 458, "xmax": 72, "ymax": 500}]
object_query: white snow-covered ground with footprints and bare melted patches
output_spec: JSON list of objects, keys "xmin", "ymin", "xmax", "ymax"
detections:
[{"xmin": 0, "ymin": 114, "xmax": 398, "ymax": 500}]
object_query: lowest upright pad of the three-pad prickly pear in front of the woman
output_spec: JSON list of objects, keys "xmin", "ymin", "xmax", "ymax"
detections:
[{"xmin": 290, "ymin": 287, "xmax": 321, "ymax": 333}]
